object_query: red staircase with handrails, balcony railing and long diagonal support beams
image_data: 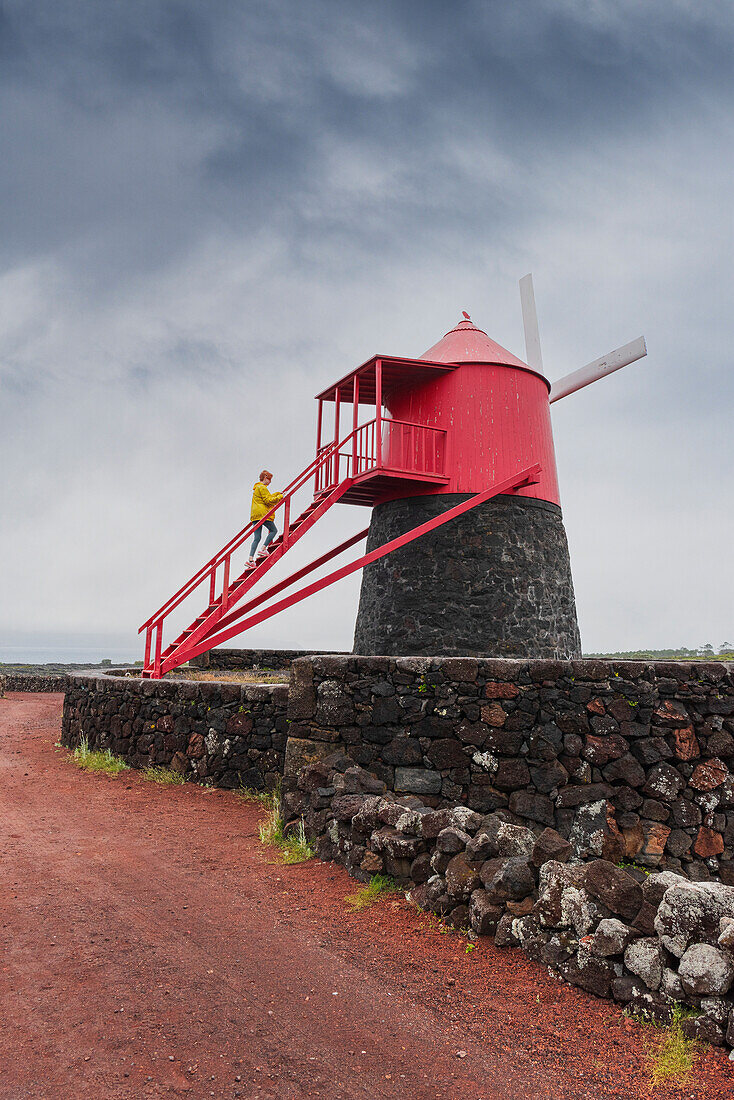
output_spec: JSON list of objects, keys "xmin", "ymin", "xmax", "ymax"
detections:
[{"xmin": 139, "ymin": 418, "xmax": 540, "ymax": 680}]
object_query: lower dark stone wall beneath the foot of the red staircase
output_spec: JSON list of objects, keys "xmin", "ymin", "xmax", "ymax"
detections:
[{"xmin": 62, "ymin": 674, "xmax": 288, "ymax": 790}]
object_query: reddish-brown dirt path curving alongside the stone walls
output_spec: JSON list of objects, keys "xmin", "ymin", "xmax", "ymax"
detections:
[{"xmin": 0, "ymin": 694, "xmax": 734, "ymax": 1100}]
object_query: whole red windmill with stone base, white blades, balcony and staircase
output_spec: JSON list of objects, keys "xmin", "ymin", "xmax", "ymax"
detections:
[{"xmin": 140, "ymin": 275, "xmax": 646, "ymax": 679}]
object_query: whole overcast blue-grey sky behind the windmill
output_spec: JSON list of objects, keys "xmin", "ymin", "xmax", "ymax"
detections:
[{"xmin": 0, "ymin": 0, "xmax": 734, "ymax": 660}]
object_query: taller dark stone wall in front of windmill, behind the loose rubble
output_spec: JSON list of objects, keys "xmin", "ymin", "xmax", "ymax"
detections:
[{"xmin": 284, "ymin": 657, "xmax": 734, "ymax": 883}]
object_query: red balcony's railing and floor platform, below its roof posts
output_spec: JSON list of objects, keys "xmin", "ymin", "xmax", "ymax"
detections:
[{"xmin": 315, "ymin": 418, "xmax": 448, "ymax": 506}]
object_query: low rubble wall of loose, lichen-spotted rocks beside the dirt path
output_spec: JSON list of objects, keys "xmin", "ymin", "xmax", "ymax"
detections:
[{"xmin": 285, "ymin": 752, "xmax": 734, "ymax": 1046}]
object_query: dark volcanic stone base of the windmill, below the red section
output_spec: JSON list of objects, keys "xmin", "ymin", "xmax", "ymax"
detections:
[{"xmin": 354, "ymin": 494, "xmax": 581, "ymax": 658}]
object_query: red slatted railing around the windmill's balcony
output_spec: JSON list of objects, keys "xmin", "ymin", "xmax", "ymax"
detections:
[{"xmin": 316, "ymin": 419, "xmax": 446, "ymax": 493}]
